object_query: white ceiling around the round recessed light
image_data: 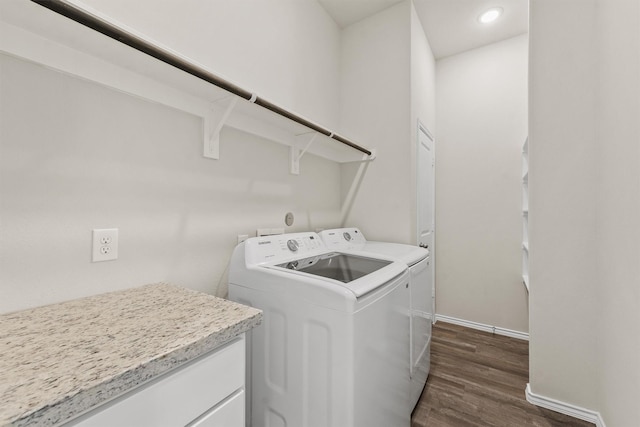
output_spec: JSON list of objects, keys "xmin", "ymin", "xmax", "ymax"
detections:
[{"xmin": 318, "ymin": 0, "xmax": 529, "ymax": 59}]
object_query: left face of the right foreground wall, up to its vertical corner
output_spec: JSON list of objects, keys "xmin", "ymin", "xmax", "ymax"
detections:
[{"xmin": 529, "ymin": 0, "xmax": 599, "ymax": 408}]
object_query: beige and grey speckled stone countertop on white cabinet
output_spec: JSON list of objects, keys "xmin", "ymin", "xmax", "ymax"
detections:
[{"xmin": 0, "ymin": 283, "xmax": 262, "ymax": 427}]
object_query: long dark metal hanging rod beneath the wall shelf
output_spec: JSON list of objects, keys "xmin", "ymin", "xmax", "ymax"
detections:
[{"xmin": 31, "ymin": 0, "xmax": 372, "ymax": 156}]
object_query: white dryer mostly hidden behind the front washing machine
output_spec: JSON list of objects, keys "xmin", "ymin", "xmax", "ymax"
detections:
[{"xmin": 319, "ymin": 227, "xmax": 434, "ymax": 409}]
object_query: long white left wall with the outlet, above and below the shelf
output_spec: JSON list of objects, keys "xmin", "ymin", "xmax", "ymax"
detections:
[{"xmin": 0, "ymin": 1, "xmax": 340, "ymax": 312}]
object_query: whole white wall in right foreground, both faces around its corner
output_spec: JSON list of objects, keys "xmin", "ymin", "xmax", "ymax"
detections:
[{"xmin": 529, "ymin": 0, "xmax": 640, "ymax": 426}]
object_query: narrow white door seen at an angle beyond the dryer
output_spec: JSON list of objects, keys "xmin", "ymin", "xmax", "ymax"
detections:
[{"xmin": 416, "ymin": 122, "xmax": 436, "ymax": 321}]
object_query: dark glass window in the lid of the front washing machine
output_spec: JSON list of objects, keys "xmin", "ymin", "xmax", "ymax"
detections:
[{"xmin": 276, "ymin": 252, "xmax": 392, "ymax": 283}]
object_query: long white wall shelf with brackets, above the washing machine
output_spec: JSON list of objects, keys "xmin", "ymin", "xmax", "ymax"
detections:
[{"xmin": 0, "ymin": 0, "xmax": 375, "ymax": 174}]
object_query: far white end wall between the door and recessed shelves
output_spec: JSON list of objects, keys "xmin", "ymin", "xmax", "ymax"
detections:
[{"xmin": 436, "ymin": 35, "xmax": 528, "ymax": 332}]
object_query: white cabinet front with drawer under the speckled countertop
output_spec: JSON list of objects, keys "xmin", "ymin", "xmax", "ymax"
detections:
[{"xmin": 65, "ymin": 334, "xmax": 245, "ymax": 427}]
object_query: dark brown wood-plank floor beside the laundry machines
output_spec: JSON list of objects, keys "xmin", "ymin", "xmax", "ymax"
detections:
[{"xmin": 411, "ymin": 322, "xmax": 593, "ymax": 427}]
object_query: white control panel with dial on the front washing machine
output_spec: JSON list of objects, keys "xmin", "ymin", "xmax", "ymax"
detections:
[{"xmin": 244, "ymin": 232, "xmax": 327, "ymax": 264}]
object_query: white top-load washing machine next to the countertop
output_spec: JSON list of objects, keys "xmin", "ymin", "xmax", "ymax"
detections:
[{"xmin": 229, "ymin": 233, "xmax": 411, "ymax": 427}]
